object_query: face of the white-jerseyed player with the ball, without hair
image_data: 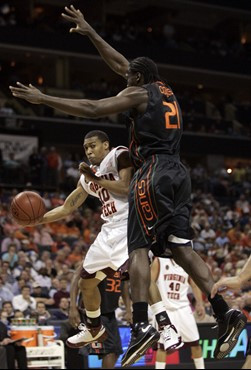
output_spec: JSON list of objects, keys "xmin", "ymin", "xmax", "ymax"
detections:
[{"xmin": 84, "ymin": 136, "xmax": 109, "ymax": 166}]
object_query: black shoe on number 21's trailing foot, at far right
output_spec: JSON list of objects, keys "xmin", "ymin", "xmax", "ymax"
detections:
[{"xmin": 214, "ymin": 310, "xmax": 247, "ymax": 360}]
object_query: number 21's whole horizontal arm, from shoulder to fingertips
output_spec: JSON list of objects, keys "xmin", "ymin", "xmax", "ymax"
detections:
[{"xmin": 10, "ymin": 82, "xmax": 148, "ymax": 118}]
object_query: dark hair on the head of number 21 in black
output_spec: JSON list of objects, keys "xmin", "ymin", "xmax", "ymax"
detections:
[{"xmin": 129, "ymin": 57, "xmax": 160, "ymax": 84}]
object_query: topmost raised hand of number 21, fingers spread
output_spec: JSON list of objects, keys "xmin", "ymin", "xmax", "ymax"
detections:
[{"xmin": 62, "ymin": 5, "xmax": 92, "ymax": 35}]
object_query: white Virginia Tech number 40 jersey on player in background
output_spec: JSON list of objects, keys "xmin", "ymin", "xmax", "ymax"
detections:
[{"xmin": 156, "ymin": 258, "xmax": 190, "ymax": 311}]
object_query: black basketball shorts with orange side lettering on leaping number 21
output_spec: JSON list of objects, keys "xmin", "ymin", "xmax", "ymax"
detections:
[{"xmin": 128, "ymin": 155, "xmax": 193, "ymax": 256}]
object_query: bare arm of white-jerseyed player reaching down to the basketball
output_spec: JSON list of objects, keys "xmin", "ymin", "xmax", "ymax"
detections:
[{"xmin": 39, "ymin": 184, "xmax": 88, "ymax": 224}]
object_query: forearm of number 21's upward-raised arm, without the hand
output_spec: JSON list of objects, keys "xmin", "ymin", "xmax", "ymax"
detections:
[{"xmin": 88, "ymin": 27, "xmax": 129, "ymax": 78}]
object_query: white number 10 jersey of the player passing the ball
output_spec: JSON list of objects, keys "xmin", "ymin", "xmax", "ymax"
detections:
[{"xmin": 80, "ymin": 146, "xmax": 128, "ymax": 222}]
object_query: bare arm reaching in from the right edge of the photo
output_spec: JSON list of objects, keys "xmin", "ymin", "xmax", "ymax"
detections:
[{"xmin": 211, "ymin": 256, "xmax": 251, "ymax": 298}]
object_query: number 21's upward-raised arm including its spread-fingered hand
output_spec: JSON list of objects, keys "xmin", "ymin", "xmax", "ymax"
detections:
[{"xmin": 62, "ymin": 5, "xmax": 129, "ymax": 78}]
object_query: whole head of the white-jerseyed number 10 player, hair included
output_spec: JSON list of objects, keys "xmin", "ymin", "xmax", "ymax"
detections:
[{"xmin": 83, "ymin": 130, "xmax": 110, "ymax": 166}]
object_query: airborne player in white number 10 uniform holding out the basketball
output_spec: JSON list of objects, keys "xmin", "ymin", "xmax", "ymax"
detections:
[{"xmin": 36, "ymin": 131, "xmax": 132, "ymax": 348}]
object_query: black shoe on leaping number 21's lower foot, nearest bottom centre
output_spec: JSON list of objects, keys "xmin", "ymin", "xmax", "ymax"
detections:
[{"xmin": 121, "ymin": 322, "xmax": 160, "ymax": 367}]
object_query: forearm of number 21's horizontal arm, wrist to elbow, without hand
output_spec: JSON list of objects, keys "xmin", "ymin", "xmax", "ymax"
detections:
[{"xmin": 40, "ymin": 94, "xmax": 96, "ymax": 118}]
